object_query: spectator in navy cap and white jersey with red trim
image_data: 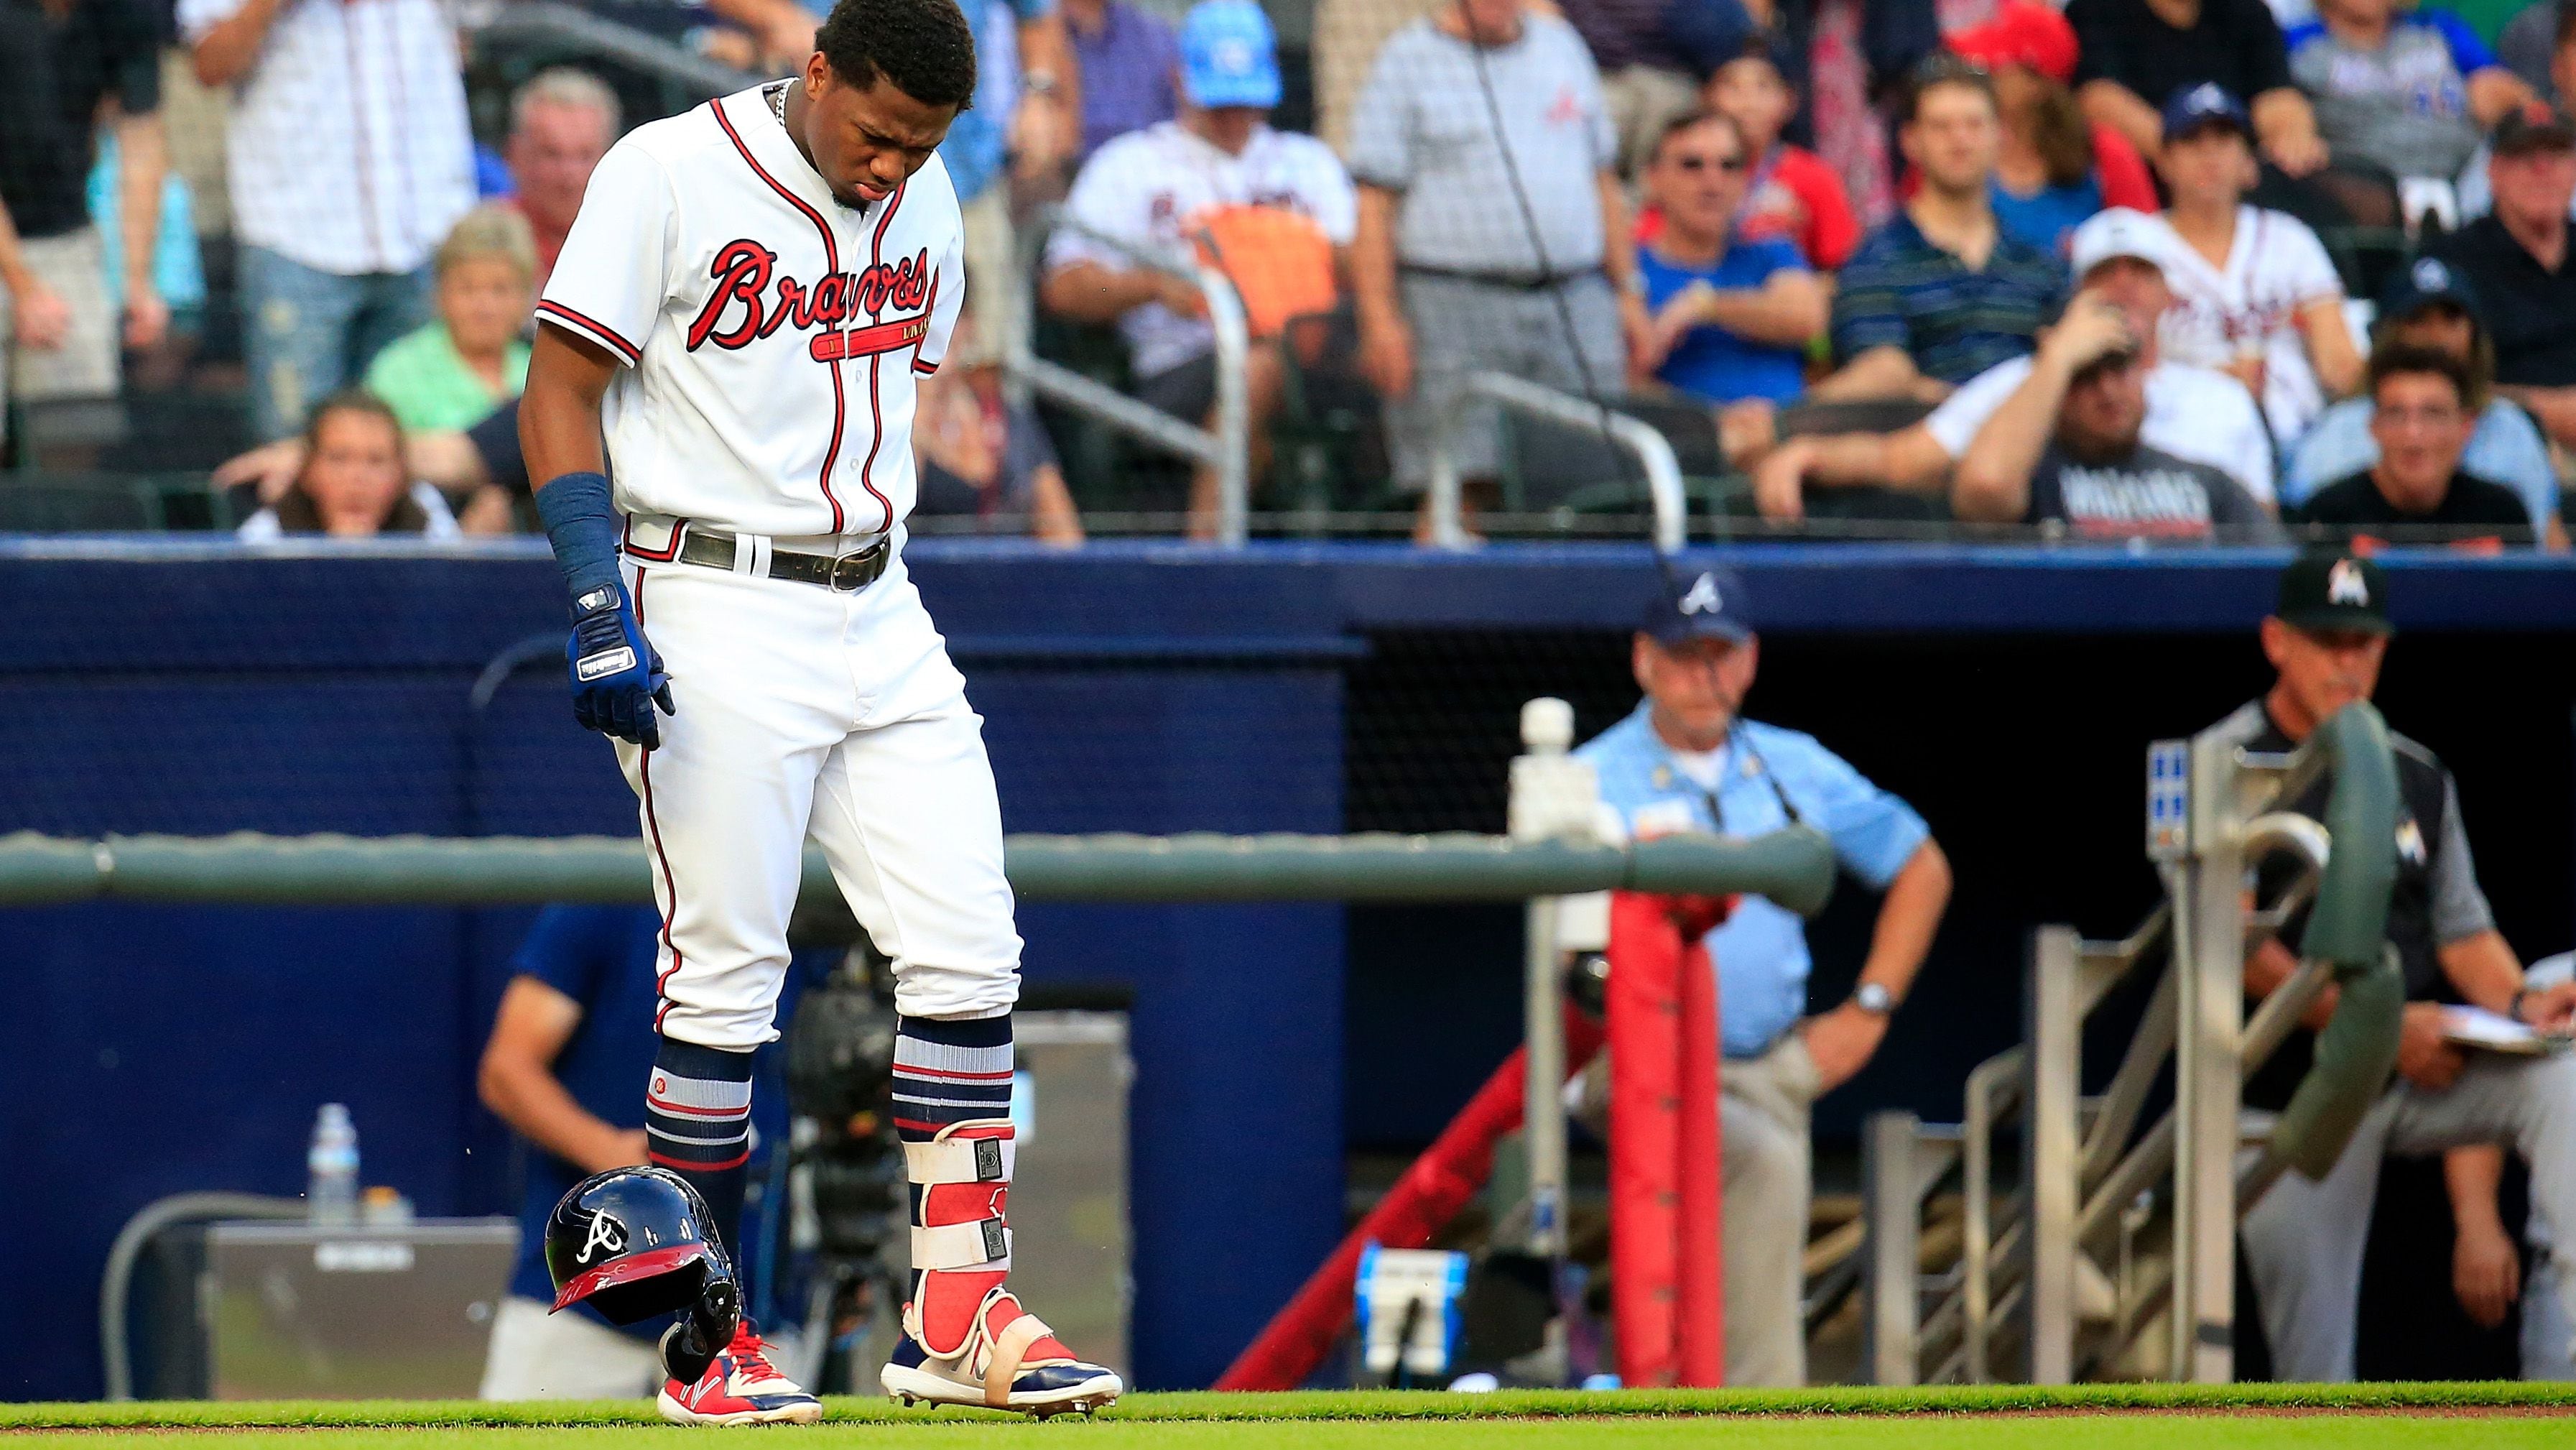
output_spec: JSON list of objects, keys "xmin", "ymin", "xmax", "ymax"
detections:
[{"xmin": 2156, "ymin": 83, "xmax": 2362, "ymax": 448}]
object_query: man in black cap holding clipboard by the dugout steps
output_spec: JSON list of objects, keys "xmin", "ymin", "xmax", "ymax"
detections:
[{"xmin": 2220, "ymin": 554, "xmax": 2576, "ymax": 1380}]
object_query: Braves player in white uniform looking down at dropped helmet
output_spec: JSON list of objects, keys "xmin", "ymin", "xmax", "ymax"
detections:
[{"xmin": 520, "ymin": 0, "xmax": 1123, "ymax": 1424}]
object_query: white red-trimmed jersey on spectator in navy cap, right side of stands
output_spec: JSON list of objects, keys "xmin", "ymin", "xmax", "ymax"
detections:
[{"xmin": 2156, "ymin": 206, "xmax": 2344, "ymax": 443}]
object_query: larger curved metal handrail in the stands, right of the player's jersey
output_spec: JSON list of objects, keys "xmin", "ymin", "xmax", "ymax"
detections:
[{"xmin": 1002, "ymin": 206, "xmax": 1252, "ymax": 548}]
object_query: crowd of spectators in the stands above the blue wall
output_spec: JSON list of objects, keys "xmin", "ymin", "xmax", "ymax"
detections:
[{"xmin": 0, "ymin": 0, "xmax": 2576, "ymax": 548}]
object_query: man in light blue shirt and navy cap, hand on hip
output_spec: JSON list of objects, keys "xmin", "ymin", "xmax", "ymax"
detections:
[{"xmin": 1577, "ymin": 569, "xmax": 1950, "ymax": 1385}]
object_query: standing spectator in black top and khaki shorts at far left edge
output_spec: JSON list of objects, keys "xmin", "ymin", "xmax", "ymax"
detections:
[{"xmin": 0, "ymin": 0, "xmax": 170, "ymax": 458}]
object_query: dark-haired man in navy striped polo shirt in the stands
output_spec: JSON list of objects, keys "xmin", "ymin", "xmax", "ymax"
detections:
[{"xmin": 1816, "ymin": 54, "xmax": 2066, "ymax": 400}]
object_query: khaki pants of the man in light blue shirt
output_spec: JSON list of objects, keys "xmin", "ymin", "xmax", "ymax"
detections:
[{"xmin": 1566, "ymin": 1033, "xmax": 1819, "ymax": 1388}]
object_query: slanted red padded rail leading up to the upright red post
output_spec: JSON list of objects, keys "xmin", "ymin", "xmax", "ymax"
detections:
[{"xmin": 1216, "ymin": 1007, "xmax": 1602, "ymax": 1391}]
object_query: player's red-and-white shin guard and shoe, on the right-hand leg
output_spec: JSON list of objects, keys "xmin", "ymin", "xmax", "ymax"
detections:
[{"xmin": 884, "ymin": 1118, "xmax": 1126, "ymax": 1414}]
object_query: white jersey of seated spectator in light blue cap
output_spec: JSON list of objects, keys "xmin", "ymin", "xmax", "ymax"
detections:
[{"xmin": 1046, "ymin": 121, "xmax": 1360, "ymax": 379}]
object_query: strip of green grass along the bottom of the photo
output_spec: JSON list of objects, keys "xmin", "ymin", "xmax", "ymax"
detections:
[{"xmin": 0, "ymin": 1383, "xmax": 2576, "ymax": 1450}]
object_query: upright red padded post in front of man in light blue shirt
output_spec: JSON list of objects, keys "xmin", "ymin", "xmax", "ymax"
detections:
[{"xmin": 1608, "ymin": 891, "xmax": 1726, "ymax": 1388}]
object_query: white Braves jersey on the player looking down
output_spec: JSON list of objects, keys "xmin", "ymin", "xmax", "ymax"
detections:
[{"xmin": 536, "ymin": 88, "xmax": 966, "ymax": 548}]
